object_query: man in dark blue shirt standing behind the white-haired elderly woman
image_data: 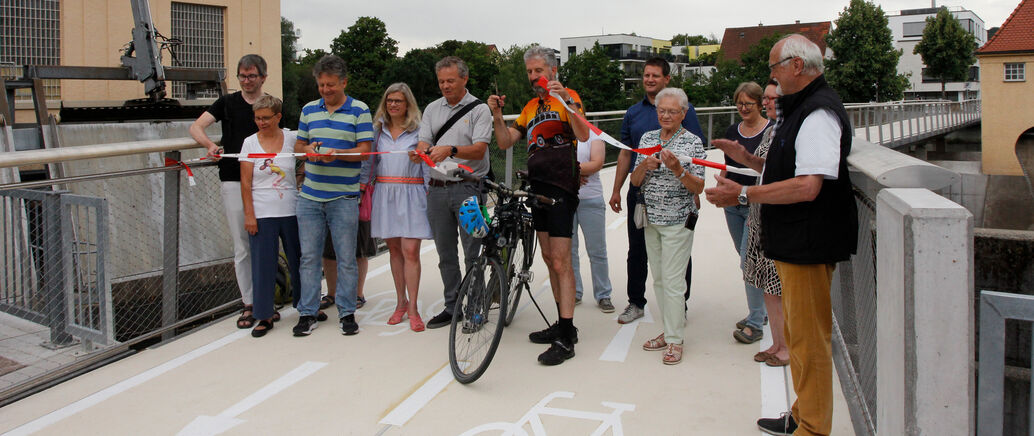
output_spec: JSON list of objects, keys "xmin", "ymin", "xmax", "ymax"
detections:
[{"xmin": 610, "ymin": 57, "xmax": 707, "ymax": 324}]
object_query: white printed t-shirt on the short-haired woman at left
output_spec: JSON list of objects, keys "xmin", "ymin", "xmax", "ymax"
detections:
[{"xmin": 240, "ymin": 129, "xmax": 298, "ymax": 219}]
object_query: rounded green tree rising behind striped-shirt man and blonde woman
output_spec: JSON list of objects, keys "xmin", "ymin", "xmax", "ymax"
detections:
[{"xmin": 330, "ymin": 17, "xmax": 398, "ymax": 107}]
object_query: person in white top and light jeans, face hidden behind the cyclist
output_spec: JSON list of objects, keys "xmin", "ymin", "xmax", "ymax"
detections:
[{"xmin": 571, "ymin": 132, "xmax": 614, "ymax": 313}]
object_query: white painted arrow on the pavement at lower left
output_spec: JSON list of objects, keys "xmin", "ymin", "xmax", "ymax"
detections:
[{"xmin": 177, "ymin": 362, "xmax": 327, "ymax": 436}]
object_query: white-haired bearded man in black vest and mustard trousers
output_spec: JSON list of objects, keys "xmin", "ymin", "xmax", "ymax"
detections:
[{"xmin": 705, "ymin": 35, "xmax": 858, "ymax": 435}]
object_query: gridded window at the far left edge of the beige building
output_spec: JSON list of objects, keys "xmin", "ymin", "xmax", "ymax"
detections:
[{"xmin": 0, "ymin": 0, "xmax": 61, "ymax": 101}]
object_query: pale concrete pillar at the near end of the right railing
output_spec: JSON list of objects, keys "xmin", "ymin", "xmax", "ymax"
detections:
[{"xmin": 876, "ymin": 188, "xmax": 975, "ymax": 435}]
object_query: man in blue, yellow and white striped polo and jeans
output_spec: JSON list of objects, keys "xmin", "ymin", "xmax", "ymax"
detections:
[{"xmin": 294, "ymin": 55, "xmax": 373, "ymax": 336}]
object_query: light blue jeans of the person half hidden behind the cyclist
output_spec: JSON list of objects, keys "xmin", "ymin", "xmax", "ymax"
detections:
[{"xmin": 571, "ymin": 196, "xmax": 613, "ymax": 302}]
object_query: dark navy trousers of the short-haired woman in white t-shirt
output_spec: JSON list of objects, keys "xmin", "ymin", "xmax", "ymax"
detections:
[{"xmin": 250, "ymin": 217, "xmax": 302, "ymax": 319}]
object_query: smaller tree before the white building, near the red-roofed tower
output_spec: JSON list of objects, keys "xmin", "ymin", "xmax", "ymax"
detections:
[{"xmin": 912, "ymin": 7, "xmax": 976, "ymax": 99}]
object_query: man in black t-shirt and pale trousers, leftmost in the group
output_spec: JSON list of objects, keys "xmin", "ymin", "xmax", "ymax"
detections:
[{"xmin": 190, "ymin": 55, "xmax": 266, "ymax": 329}]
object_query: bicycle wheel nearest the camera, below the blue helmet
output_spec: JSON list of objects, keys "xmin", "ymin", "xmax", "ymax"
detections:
[{"xmin": 449, "ymin": 256, "xmax": 507, "ymax": 383}]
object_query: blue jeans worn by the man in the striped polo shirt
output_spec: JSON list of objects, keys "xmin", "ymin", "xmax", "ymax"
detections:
[{"xmin": 296, "ymin": 195, "xmax": 359, "ymax": 317}]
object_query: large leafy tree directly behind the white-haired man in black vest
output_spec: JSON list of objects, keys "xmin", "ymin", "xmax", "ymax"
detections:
[{"xmin": 826, "ymin": 0, "xmax": 908, "ymax": 102}]
